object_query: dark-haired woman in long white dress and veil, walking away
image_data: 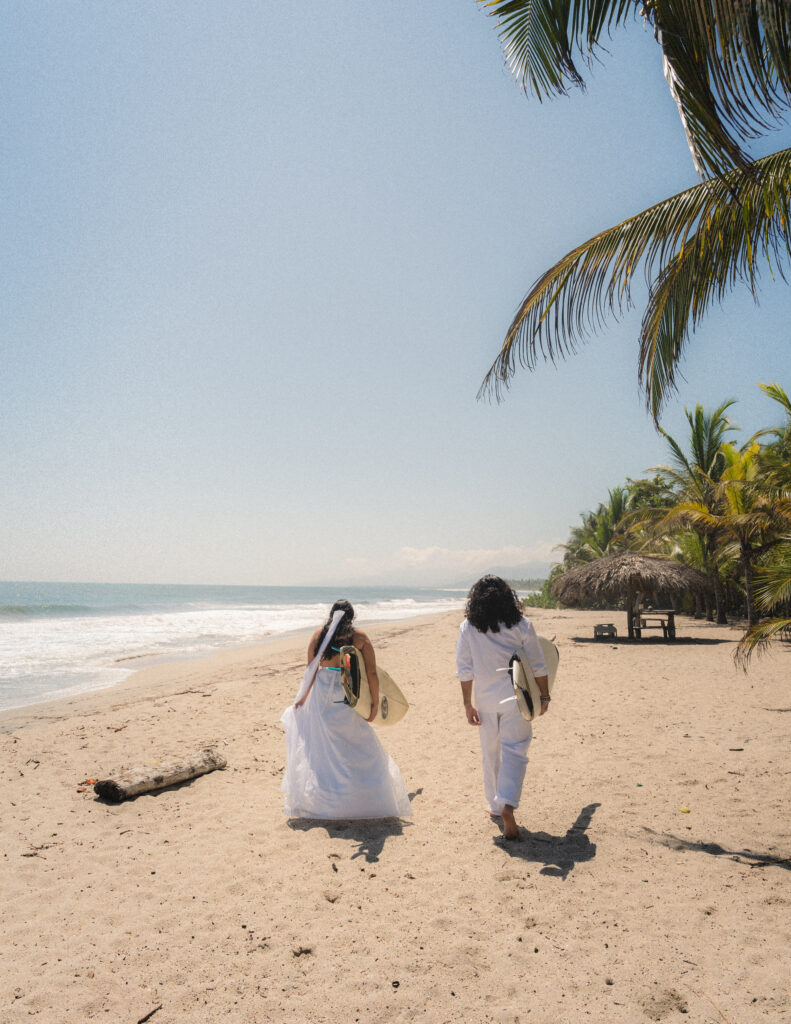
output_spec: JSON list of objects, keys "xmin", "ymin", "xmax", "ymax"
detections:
[{"xmin": 281, "ymin": 601, "xmax": 412, "ymax": 819}]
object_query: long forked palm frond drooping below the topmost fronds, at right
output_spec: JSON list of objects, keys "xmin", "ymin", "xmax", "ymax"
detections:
[{"xmin": 478, "ymin": 148, "xmax": 791, "ymax": 419}]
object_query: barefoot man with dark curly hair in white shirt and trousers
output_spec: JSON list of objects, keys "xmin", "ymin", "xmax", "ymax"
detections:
[{"xmin": 456, "ymin": 575, "xmax": 550, "ymax": 840}]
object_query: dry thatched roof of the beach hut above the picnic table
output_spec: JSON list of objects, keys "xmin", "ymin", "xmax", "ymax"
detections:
[{"xmin": 552, "ymin": 551, "xmax": 711, "ymax": 607}]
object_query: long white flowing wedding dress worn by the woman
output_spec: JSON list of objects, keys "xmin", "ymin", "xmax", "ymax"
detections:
[{"xmin": 281, "ymin": 669, "xmax": 412, "ymax": 819}]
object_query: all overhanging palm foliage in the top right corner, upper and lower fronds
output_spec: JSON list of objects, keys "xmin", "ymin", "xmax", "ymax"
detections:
[{"xmin": 478, "ymin": 0, "xmax": 791, "ymax": 421}]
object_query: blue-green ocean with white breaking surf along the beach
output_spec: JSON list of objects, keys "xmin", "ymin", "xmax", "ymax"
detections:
[{"xmin": 0, "ymin": 583, "xmax": 466, "ymax": 710}]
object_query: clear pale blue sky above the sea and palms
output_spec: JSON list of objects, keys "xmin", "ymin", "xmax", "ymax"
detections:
[{"xmin": 0, "ymin": 0, "xmax": 791, "ymax": 585}]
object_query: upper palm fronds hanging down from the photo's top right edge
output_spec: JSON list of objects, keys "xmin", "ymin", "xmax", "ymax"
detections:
[{"xmin": 478, "ymin": 0, "xmax": 791, "ymax": 177}]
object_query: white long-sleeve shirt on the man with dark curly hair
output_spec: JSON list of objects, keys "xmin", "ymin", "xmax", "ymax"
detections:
[{"xmin": 456, "ymin": 615, "xmax": 546, "ymax": 712}]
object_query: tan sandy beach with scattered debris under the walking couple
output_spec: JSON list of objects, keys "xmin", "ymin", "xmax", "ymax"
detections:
[{"xmin": 0, "ymin": 609, "xmax": 791, "ymax": 1024}]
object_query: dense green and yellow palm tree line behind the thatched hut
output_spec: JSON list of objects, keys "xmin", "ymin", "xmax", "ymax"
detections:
[{"xmin": 529, "ymin": 384, "xmax": 791, "ymax": 658}]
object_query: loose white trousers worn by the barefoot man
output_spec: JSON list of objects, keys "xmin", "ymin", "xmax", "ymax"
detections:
[{"xmin": 478, "ymin": 707, "xmax": 533, "ymax": 814}]
